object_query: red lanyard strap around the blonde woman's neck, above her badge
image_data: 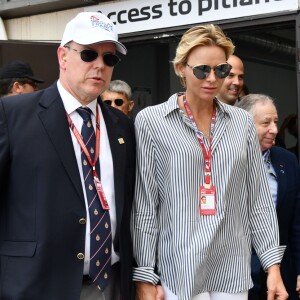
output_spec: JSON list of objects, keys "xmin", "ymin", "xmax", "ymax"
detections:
[{"xmin": 183, "ymin": 94, "xmax": 216, "ymax": 186}]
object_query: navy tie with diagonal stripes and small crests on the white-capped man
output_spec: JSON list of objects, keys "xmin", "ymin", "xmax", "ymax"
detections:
[{"xmin": 77, "ymin": 107, "xmax": 112, "ymax": 290}]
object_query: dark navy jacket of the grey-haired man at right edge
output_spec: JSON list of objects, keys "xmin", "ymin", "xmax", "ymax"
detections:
[{"xmin": 249, "ymin": 147, "xmax": 300, "ymax": 300}]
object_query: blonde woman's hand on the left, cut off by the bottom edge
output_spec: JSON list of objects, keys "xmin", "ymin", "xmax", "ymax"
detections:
[{"xmin": 135, "ymin": 282, "xmax": 164, "ymax": 300}]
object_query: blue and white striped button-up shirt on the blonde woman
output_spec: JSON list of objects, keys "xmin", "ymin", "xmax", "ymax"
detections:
[{"xmin": 132, "ymin": 94, "xmax": 285, "ymax": 300}]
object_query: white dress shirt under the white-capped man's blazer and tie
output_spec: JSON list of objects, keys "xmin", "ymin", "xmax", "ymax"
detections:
[{"xmin": 57, "ymin": 81, "xmax": 120, "ymax": 274}]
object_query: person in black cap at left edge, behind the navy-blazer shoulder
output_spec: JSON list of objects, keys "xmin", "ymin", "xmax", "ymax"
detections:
[{"xmin": 0, "ymin": 60, "xmax": 44, "ymax": 96}]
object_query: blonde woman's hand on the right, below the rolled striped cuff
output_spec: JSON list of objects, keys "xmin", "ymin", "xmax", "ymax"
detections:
[{"xmin": 267, "ymin": 265, "xmax": 289, "ymax": 300}]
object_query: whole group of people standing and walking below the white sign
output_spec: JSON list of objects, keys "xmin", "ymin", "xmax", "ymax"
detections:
[{"xmin": 0, "ymin": 12, "xmax": 300, "ymax": 300}]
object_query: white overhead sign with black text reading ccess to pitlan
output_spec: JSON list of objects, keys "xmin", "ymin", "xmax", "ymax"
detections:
[{"xmin": 84, "ymin": 0, "xmax": 298, "ymax": 34}]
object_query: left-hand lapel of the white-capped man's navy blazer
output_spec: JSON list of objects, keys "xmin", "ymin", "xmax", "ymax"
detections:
[{"xmin": 39, "ymin": 83, "xmax": 84, "ymax": 201}]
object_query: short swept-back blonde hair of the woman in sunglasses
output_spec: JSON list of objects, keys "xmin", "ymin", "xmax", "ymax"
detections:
[{"xmin": 173, "ymin": 24, "xmax": 235, "ymax": 87}]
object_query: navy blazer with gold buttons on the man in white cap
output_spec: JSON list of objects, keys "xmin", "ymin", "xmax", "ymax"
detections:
[{"xmin": 0, "ymin": 83, "xmax": 135, "ymax": 300}]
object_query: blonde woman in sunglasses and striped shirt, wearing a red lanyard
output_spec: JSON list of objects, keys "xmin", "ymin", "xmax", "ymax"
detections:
[{"xmin": 132, "ymin": 25, "xmax": 287, "ymax": 300}]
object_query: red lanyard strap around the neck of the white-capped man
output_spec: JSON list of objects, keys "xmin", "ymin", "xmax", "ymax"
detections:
[{"xmin": 66, "ymin": 105, "xmax": 100, "ymax": 179}]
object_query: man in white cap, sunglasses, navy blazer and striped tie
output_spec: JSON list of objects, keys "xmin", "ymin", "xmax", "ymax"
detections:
[{"xmin": 0, "ymin": 12, "xmax": 135, "ymax": 300}]
